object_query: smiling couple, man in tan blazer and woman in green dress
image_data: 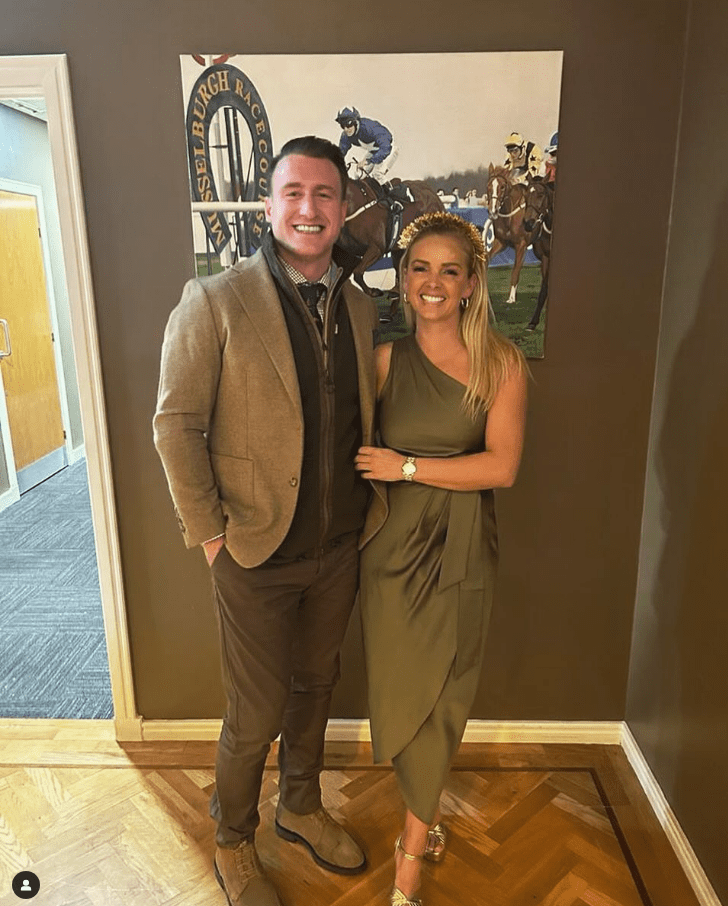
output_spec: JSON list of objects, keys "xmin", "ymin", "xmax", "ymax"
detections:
[{"xmin": 154, "ymin": 136, "xmax": 525, "ymax": 906}]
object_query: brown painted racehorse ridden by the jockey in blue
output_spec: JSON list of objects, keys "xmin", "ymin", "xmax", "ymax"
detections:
[{"xmin": 344, "ymin": 179, "xmax": 445, "ymax": 295}]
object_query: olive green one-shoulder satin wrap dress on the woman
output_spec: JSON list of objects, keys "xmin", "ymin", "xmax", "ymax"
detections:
[{"xmin": 361, "ymin": 335, "xmax": 498, "ymax": 824}]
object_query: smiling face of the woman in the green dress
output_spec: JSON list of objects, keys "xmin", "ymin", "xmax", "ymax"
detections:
[{"xmin": 404, "ymin": 234, "xmax": 475, "ymax": 325}]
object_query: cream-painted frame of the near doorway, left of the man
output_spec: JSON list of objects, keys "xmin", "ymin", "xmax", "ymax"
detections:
[{"xmin": 0, "ymin": 54, "xmax": 141, "ymax": 739}]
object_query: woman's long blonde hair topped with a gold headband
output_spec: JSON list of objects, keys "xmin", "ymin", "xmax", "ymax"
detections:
[{"xmin": 399, "ymin": 211, "xmax": 528, "ymax": 418}]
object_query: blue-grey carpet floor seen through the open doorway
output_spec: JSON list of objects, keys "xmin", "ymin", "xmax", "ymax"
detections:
[{"xmin": 0, "ymin": 460, "xmax": 113, "ymax": 718}]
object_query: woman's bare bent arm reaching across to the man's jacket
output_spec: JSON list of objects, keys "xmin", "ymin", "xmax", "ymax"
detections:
[{"xmin": 355, "ymin": 360, "xmax": 527, "ymax": 491}]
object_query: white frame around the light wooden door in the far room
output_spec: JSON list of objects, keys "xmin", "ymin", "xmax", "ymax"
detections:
[{"xmin": 0, "ymin": 176, "xmax": 75, "ymax": 502}]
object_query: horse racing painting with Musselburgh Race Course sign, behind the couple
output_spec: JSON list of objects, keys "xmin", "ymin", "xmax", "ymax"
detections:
[{"xmin": 180, "ymin": 51, "xmax": 563, "ymax": 358}]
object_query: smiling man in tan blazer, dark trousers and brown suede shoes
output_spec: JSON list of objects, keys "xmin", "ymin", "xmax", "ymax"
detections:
[{"xmin": 154, "ymin": 136, "xmax": 377, "ymax": 906}]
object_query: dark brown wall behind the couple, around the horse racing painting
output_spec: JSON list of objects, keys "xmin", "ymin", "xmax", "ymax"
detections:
[{"xmin": 0, "ymin": 0, "xmax": 686, "ymax": 720}]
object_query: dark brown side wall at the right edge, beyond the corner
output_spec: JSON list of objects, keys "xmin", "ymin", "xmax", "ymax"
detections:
[{"xmin": 627, "ymin": 0, "xmax": 728, "ymax": 903}]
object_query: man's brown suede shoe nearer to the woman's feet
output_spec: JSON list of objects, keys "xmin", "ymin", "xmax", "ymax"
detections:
[{"xmin": 276, "ymin": 802, "xmax": 367, "ymax": 875}]
